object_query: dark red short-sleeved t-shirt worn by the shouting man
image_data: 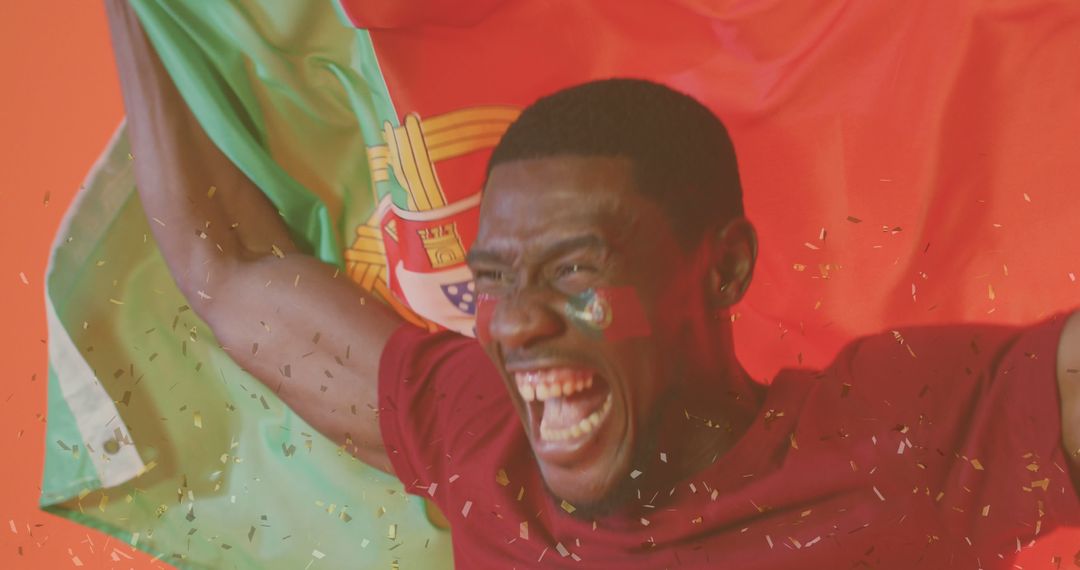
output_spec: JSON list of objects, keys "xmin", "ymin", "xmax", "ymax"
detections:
[{"xmin": 379, "ymin": 316, "xmax": 1080, "ymax": 570}]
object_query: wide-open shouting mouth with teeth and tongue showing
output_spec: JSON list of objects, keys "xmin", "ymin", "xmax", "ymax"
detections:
[{"xmin": 514, "ymin": 368, "xmax": 611, "ymax": 448}]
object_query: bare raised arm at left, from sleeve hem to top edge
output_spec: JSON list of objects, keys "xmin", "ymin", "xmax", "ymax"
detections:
[{"xmin": 106, "ymin": 0, "xmax": 401, "ymax": 472}]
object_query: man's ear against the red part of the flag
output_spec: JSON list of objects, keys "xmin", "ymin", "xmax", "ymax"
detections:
[{"xmin": 705, "ymin": 217, "xmax": 757, "ymax": 309}]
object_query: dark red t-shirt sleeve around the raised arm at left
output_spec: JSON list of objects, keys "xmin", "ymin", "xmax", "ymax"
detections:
[{"xmin": 379, "ymin": 325, "xmax": 512, "ymax": 503}]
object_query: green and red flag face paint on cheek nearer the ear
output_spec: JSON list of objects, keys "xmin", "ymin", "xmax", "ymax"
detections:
[{"xmin": 566, "ymin": 287, "xmax": 652, "ymax": 340}]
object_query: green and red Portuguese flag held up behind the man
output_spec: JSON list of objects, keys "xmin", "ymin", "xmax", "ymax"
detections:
[{"xmin": 41, "ymin": 0, "xmax": 1080, "ymax": 569}]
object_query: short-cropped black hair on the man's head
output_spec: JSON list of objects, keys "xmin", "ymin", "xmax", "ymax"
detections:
[{"xmin": 487, "ymin": 79, "xmax": 743, "ymax": 248}]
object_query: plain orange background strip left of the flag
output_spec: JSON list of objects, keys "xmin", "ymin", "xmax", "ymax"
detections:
[{"xmin": 0, "ymin": 0, "xmax": 167, "ymax": 569}]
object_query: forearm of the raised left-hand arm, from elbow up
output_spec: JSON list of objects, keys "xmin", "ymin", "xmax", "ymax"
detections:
[{"xmin": 106, "ymin": 0, "xmax": 296, "ymax": 298}]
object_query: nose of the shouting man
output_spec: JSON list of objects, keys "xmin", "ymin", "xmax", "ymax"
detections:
[{"xmin": 490, "ymin": 289, "xmax": 565, "ymax": 351}]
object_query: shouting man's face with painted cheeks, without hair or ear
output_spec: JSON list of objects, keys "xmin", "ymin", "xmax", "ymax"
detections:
[{"xmin": 469, "ymin": 157, "xmax": 700, "ymax": 506}]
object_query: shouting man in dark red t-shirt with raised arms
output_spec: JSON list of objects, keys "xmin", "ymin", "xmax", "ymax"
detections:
[{"xmin": 110, "ymin": 3, "xmax": 1080, "ymax": 568}]
